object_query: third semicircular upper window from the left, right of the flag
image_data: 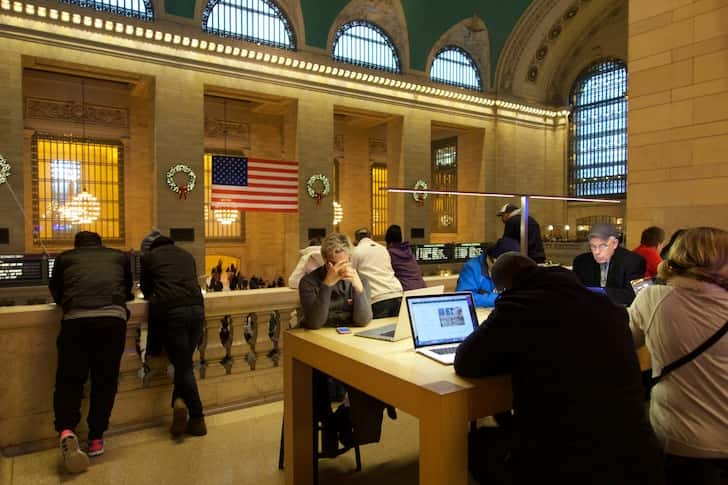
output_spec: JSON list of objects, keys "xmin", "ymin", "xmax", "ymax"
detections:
[{"xmin": 332, "ymin": 20, "xmax": 402, "ymax": 72}]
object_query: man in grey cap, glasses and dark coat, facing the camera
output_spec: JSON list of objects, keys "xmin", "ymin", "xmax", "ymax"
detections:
[{"xmin": 573, "ymin": 223, "xmax": 645, "ymax": 305}]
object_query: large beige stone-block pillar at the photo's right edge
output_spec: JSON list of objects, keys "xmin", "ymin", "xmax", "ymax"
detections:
[{"xmin": 627, "ymin": 0, "xmax": 728, "ymax": 247}]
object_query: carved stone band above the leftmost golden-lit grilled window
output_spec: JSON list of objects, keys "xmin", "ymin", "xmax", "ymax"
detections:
[{"xmin": 25, "ymin": 97, "xmax": 129, "ymax": 128}]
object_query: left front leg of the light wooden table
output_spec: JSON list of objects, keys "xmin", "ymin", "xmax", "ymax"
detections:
[{"xmin": 283, "ymin": 349, "xmax": 314, "ymax": 485}]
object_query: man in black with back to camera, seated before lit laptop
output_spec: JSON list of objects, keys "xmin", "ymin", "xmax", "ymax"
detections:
[{"xmin": 455, "ymin": 253, "xmax": 663, "ymax": 485}]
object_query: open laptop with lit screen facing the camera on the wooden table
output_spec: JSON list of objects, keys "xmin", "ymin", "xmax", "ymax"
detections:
[{"xmin": 407, "ymin": 292, "xmax": 478, "ymax": 365}]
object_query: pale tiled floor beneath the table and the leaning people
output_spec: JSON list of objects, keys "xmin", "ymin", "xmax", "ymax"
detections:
[{"xmin": 0, "ymin": 402, "xmax": 438, "ymax": 485}]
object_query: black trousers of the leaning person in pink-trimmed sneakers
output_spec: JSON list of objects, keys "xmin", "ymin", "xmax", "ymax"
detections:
[{"xmin": 53, "ymin": 317, "xmax": 126, "ymax": 439}]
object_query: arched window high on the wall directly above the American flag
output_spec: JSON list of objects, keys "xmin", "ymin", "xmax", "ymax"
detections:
[{"xmin": 202, "ymin": 0, "xmax": 296, "ymax": 50}]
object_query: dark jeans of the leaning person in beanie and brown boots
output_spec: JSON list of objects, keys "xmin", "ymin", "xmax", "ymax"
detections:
[{"xmin": 163, "ymin": 305, "xmax": 205, "ymax": 418}]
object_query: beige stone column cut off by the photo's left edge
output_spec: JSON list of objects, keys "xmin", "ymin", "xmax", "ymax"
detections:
[{"xmin": 0, "ymin": 49, "xmax": 25, "ymax": 253}]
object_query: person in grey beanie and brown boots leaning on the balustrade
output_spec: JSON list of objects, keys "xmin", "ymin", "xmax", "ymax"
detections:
[{"xmin": 141, "ymin": 236, "xmax": 207, "ymax": 437}]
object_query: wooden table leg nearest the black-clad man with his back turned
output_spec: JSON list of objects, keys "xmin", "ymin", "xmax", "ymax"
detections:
[{"xmin": 420, "ymin": 396, "xmax": 468, "ymax": 485}]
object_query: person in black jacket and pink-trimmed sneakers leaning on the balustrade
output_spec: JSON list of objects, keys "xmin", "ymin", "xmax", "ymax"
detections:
[{"xmin": 48, "ymin": 231, "xmax": 134, "ymax": 473}]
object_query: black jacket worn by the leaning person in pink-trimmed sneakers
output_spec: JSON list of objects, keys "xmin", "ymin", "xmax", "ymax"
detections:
[{"xmin": 48, "ymin": 241, "xmax": 134, "ymax": 312}]
